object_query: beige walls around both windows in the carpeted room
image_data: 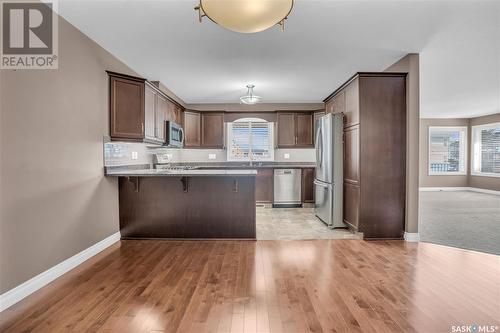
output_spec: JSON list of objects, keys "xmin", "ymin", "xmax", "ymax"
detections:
[{"xmin": 420, "ymin": 113, "xmax": 500, "ymax": 191}]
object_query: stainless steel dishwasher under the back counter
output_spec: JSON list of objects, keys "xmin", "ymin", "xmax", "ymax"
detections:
[{"xmin": 273, "ymin": 169, "xmax": 302, "ymax": 207}]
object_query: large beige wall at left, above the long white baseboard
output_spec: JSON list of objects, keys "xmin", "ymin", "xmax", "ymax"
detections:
[{"xmin": 0, "ymin": 15, "xmax": 140, "ymax": 293}]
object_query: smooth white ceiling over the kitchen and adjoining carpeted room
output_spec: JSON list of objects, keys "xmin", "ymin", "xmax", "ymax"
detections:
[{"xmin": 59, "ymin": 0, "xmax": 500, "ymax": 117}]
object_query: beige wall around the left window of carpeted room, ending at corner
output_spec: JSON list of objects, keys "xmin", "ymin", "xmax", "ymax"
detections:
[{"xmin": 420, "ymin": 119, "xmax": 470, "ymax": 187}]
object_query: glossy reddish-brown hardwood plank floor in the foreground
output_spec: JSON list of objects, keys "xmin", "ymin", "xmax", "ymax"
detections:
[{"xmin": 0, "ymin": 240, "xmax": 500, "ymax": 333}]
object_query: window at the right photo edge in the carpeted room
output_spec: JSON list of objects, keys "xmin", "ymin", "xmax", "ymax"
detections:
[{"xmin": 471, "ymin": 123, "xmax": 500, "ymax": 177}]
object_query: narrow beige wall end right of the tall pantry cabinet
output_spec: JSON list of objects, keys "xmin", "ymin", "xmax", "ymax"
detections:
[{"xmin": 385, "ymin": 54, "xmax": 420, "ymax": 233}]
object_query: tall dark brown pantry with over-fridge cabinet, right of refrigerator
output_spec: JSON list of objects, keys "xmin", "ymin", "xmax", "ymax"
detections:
[{"xmin": 324, "ymin": 73, "xmax": 406, "ymax": 239}]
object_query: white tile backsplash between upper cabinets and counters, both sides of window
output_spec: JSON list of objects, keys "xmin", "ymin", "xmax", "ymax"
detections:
[{"xmin": 104, "ymin": 141, "xmax": 316, "ymax": 166}]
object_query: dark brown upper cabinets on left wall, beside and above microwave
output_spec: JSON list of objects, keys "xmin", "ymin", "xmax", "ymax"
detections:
[{"xmin": 108, "ymin": 72, "xmax": 182, "ymax": 144}]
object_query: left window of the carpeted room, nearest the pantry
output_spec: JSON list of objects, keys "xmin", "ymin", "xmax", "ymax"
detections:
[{"xmin": 429, "ymin": 127, "xmax": 467, "ymax": 175}]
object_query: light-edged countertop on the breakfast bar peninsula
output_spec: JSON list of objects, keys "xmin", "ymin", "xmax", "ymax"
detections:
[{"xmin": 106, "ymin": 169, "xmax": 257, "ymax": 177}]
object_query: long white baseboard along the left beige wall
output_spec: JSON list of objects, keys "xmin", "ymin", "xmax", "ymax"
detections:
[{"xmin": 0, "ymin": 232, "xmax": 120, "ymax": 312}]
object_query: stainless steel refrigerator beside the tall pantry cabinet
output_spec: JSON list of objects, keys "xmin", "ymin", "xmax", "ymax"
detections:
[{"xmin": 314, "ymin": 114, "xmax": 347, "ymax": 228}]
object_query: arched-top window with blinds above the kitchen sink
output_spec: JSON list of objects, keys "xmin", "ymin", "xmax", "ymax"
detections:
[{"xmin": 227, "ymin": 118, "xmax": 274, "ymax": 161}]
